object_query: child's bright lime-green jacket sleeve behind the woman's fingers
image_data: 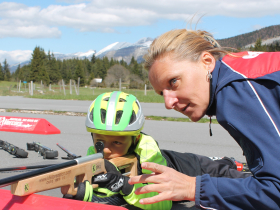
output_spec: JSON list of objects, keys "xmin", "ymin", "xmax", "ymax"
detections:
[{"xmin": 123, "ymin": 134, "xmax": 172, "ymax": 210}]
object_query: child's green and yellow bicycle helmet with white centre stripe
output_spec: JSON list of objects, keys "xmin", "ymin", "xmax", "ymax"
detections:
[{"xmin": 86, "ymin": 91, "xmax": 145, "ymax": 136}]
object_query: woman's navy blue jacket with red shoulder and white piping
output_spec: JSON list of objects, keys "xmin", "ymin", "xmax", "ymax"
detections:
[{"xmin": 195, "ymin": 52, "xmax": 280, "ymax": 210}]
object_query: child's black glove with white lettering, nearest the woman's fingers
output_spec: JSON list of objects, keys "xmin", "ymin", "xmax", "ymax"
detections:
[{"xmin": 92, "ymin": 160, "xmax": 133, "ymax": 195}]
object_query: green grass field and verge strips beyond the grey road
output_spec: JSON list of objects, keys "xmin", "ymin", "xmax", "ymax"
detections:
[{"xmin": 0, "ymin": 81, "xmax": 218, "ymax": 124}]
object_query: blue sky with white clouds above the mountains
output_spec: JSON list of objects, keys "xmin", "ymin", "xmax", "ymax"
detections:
[{"xmin": 0, "ymin": 0, "xmax": 280, "ymax": 65}]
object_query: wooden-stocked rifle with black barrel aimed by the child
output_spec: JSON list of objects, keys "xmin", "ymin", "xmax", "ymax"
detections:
[{"xmin": 0, "ymin": 148, "xmax": 137, "ymax": 196}]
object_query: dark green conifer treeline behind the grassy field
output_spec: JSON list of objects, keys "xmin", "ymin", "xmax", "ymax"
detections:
[{"xmin": 0, "ymin": 38, "xmax": 280, "ymax": 89}]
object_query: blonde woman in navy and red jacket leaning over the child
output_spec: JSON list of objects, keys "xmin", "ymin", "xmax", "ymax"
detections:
[{"xmin": 129, "ymin": 29, "xmax": 280, "ymax": 210}]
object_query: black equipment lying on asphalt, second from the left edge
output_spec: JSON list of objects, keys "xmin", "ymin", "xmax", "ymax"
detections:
[{"xmin": 26, "ymin": 142, "xmax": 58, "ymax": 159}]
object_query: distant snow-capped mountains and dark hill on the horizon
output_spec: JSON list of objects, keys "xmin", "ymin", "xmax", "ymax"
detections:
[{"xmin": 10, "ymin": 25, "xmax": 280, "ymax": 72}]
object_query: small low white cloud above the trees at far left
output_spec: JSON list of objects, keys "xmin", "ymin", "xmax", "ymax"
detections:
[{"xmin": 0, "ymin": 50, "xmax": 33, "ymax": 65}]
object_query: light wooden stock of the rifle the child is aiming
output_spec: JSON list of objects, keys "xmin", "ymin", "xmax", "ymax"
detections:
[{"xmin": 7, "ymin": 155, "xmax": 137, "ymax": 196}]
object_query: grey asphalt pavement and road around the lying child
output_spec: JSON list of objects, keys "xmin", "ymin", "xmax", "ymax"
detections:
[{"xmin": 0, "ymin": 96, "xmax": 245, "ymax": 210}]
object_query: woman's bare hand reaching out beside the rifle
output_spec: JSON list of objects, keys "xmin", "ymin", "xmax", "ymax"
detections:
[{"xmin": 128, "ymin": 162, "xmax": 196, "ymax": 204}]
